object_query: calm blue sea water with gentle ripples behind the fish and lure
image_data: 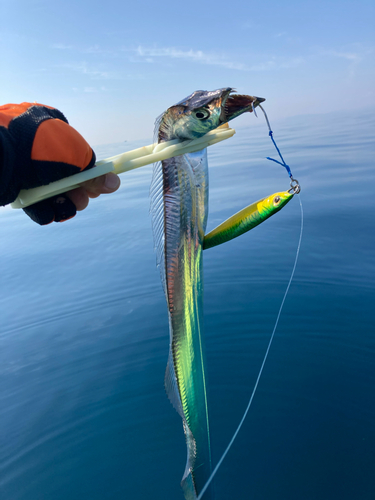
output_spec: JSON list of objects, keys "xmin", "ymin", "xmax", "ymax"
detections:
[{"xmin": 0, "ymin": 110, "xmax": 375, "ymax": 500}]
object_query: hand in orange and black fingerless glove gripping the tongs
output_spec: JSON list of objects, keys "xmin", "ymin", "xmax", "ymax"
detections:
[{"xmin": 0, "ymin": 103, "xmax": 120, "ymax": 225}]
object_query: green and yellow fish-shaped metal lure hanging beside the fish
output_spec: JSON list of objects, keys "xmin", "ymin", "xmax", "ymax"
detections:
[{"xmin": 203, "ymin": 191, "xmax": 294, "ymax": 250}]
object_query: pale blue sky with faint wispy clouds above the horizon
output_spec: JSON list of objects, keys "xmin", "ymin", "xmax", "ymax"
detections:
[{"xmin": 0, "ymin": 0, "xmax": 375, "ymax": 145}]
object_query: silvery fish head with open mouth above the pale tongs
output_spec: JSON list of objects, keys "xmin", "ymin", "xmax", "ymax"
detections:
[{"xmin": 156, "ymin": 87, "xmax": 265, "ymax": 142}]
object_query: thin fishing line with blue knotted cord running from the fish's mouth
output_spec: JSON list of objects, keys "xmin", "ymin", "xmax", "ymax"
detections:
[{"xmin": 197, "ymin": 105, "xmax": 303, "ymax": 500}]
